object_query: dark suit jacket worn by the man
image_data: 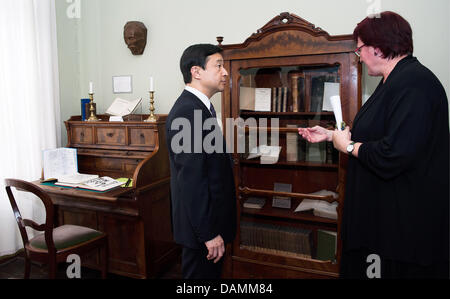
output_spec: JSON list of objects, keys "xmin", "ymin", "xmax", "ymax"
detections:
[{"xmin": 166, "ymin": 90, "xmax": 236, "ymax": 248}]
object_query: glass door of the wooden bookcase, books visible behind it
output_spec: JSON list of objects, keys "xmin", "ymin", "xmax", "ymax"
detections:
[{"xmin": 237, "ymin": 65, "xmax": 341, "ymax": 264}]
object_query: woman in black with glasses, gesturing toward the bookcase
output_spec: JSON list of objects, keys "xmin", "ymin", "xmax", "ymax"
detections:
[{"xmin": 299, "ymin": 12, "xmax": 450, "ymax": 278}]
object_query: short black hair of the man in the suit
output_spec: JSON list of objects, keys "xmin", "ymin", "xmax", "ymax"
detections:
[{"xmin": 180, "ymin": 44, "xmax": 223, "ymax": 84}]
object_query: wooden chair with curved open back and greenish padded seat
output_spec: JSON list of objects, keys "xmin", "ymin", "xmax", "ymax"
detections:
[{"xmin": 5, "ymin": 179, "xmax": 108, "ymax": 278}]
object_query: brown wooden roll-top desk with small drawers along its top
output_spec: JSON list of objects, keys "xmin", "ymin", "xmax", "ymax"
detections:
[{"xmin": 40, "ymin": 115, "xmax": 179, "ymax": 278}]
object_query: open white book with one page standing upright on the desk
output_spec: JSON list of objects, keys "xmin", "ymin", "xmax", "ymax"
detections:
[{"xmin": 42, "ymin": 147, "xmax": 98, "ymax": 184}]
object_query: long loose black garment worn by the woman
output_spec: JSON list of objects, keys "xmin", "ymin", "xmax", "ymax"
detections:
[{"xmin": 342, "ymin": 56, "xmax": 450, "ymax": 265}]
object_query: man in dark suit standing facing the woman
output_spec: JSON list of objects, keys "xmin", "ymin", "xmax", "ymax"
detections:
[{"xmin": 166, "ymin": 44, "xmax": 236, "ymax": 279}]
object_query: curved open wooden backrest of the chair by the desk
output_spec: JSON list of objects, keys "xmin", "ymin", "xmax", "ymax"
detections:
[{"xmin": 5, "ymin": 179, "xmax": 56, "ymax": 253}]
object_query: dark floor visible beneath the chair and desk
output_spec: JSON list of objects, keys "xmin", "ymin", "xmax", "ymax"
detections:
[{"xmin": 0, "ymin": 257, "xmax": 181, "ymax": 279}]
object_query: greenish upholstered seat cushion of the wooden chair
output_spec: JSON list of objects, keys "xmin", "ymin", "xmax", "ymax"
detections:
[{"xmin": 30, "ymin": 224, "xmax": 102, "ymax": 250}]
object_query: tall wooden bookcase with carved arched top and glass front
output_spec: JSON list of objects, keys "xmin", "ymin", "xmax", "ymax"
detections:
[{"xmin": 218, "ymin": 13, "xmax": 361, "ymax": 278}]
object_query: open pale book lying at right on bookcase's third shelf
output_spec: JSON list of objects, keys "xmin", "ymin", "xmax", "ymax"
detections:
[{"xmin": 294, "ymin": 190, "xmax": 339, "ymax": 219}]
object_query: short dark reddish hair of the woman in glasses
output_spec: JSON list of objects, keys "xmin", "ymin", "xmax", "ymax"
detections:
[{"xmin": 353, "ymin": 11, "xmax": 414, "ymax": 58}]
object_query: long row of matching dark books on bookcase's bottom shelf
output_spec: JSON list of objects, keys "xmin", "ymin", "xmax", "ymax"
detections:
[{"xmin": 241, "ymin": 221, "xmax": 313, "ymax": 258}]
